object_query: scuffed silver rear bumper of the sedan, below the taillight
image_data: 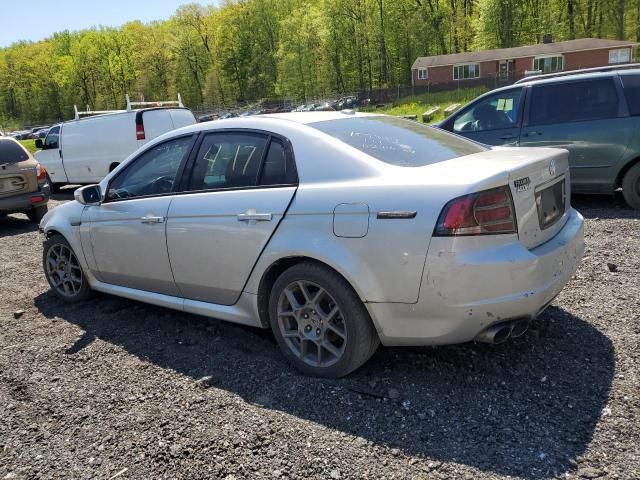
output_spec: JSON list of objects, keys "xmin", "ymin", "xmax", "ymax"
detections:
[{"xmin": 366, "ymin": 209, "xmax": 584, "ymax": 345}]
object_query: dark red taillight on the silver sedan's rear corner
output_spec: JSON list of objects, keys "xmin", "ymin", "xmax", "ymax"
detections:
[{"xmin": 435, "ymin": 186, "xmax": 516, "ymax": 236}]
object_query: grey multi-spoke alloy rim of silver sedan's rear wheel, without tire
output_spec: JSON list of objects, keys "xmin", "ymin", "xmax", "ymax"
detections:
[{"xmin": 277, "ymin": 280, "xmax": 347, "ymax": 367}]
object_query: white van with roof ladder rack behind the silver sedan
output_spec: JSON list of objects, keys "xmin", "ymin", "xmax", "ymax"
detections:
[{"xmin": 35, "ymin": 98, "xmax": 196, "ymax": 189}]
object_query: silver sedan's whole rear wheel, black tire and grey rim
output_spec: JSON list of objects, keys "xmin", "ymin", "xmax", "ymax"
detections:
[{"xmin": 269, "ymin": 262, "xmax": 379, "ymax": 378}]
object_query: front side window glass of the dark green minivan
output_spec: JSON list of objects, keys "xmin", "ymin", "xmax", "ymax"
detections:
[{"xmin": 453, "ymin": 88, "xmax": 522, "ymax": 132}]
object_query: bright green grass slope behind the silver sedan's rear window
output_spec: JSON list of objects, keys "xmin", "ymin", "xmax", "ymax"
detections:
[{"xmin": 370, "ymin": 87, "xmax": 489, "ymax": 123}]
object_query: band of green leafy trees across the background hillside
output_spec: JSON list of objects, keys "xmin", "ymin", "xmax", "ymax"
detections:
[{"xmin": 0, "ymin": 0, "xmax": 640, "ymax": 124}]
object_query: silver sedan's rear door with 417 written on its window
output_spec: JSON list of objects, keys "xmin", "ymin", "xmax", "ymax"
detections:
[{"xmin": 167, "ymin": 132, "xmax": 297, "ymax": 305}]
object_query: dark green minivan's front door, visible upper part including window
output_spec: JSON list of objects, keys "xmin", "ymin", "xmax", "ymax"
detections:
[{"xmin": 445, "ymin": 87, "xmax": 524, "ymax": 145}]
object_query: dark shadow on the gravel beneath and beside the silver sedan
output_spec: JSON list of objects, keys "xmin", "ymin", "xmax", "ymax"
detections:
[{"xmin": 36, "ymin": 293, "xmax": 614, "ymax": 479}]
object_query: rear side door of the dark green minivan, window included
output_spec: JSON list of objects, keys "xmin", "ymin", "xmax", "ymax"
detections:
[{"xmin": 520, "ymin": 77, "xmax": 633, "ymax": 193}]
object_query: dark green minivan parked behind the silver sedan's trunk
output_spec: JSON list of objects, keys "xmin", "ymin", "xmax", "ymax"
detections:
[{"xmin": 436, "ymin": 69, "xmax": 640, "ymax": 209}]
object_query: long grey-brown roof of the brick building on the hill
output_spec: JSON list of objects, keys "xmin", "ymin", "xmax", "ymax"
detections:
[{"xmin": 411, "ymin": 38, "xmax": 640, "ymax": 69}]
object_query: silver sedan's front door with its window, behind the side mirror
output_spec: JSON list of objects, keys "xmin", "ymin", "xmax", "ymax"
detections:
[{"xmin": 83, "ymin": 135, "xmax": 193, "ymax": 296}]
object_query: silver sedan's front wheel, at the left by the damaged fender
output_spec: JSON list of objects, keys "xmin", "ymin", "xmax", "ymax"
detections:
[{"xmin": 42, "ymin": 235, "xmax": 91, "ymax": 303}]
